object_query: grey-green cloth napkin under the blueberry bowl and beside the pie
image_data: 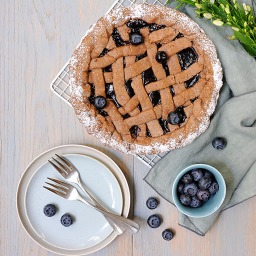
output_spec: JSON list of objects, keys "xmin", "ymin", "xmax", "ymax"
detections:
[{"xmin": 145, "ymin": 1, "xmax": 256, "ymax": 235}]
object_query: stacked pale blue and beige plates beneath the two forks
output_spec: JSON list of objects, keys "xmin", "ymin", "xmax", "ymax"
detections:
[{"xmin": 17, "ymin": 145, "xmax": 130, "ymax": 255}]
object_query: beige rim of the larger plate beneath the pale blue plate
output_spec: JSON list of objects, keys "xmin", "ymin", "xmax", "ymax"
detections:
[{"xmin": 16, "ymin": 144, "xmax": 131, "ymax": 255}]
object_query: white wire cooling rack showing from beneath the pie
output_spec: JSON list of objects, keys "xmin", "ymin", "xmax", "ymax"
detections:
[{"xmin": 51, "ymin": 0, "xmax": 170, "ymax": 168}]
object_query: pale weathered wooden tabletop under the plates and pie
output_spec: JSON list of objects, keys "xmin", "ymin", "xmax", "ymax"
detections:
[{"xmin": 0, "ymin": 0, "xmax": 256, "ymax": 256}]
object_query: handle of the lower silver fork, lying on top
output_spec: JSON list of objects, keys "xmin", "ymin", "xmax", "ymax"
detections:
[{"xmin": 79, "ymin": 196, "xmax": 140, "ymax": 234}]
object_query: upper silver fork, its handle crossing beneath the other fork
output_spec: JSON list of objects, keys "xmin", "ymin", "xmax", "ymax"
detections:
[{"xmin": 49, "ymin": 154, "xmax": 140, "ymax": 234}]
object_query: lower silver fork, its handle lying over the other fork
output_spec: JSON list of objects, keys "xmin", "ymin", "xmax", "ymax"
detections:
[{"xmin": 43, "ymin": 178, "xmax": 140, "ymax": 233}]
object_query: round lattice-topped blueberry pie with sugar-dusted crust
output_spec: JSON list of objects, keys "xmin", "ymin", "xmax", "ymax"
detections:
[{"xmin": 70, "ymin": 4, "xmax": 222, "ymax": 154}]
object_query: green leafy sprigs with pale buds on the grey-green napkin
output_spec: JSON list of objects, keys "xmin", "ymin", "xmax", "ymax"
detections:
[{"xmin": 166, "ymin": 0, "xmax": 256, "ymax": 56}]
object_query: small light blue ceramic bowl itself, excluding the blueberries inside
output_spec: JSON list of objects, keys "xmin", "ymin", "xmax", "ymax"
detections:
[{"xmin": 172, "ymin": 164, "xmax": 226, "ymax": 218}]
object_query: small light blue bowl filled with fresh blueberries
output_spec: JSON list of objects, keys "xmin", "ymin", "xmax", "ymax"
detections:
[{"xmin": 172, "ymin": 164, "xmax": 226, "ymax": 218}]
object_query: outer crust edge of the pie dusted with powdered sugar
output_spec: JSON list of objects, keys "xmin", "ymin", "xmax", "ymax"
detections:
[{"xmin": 70, "ymin": 4, "xmax": 223, "ymax": 154}]
